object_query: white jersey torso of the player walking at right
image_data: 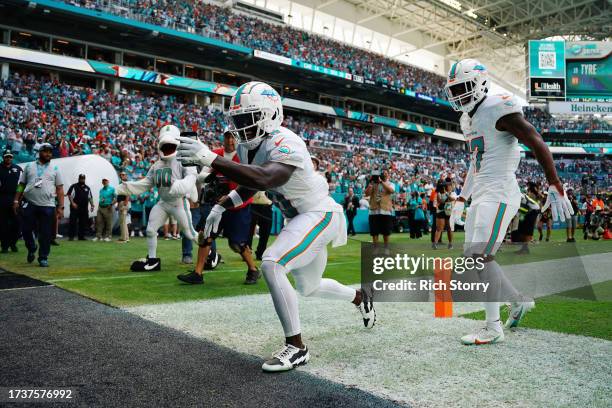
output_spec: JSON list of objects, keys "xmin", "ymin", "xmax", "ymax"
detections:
[{"xmin": 461, "ymin": 94, "xmax": 523, "ymax": 206}]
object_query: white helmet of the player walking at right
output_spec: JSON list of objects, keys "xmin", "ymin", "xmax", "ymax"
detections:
[{"xmin": 444, "ymin": 59, "xmax": 489, "ymax": 112}]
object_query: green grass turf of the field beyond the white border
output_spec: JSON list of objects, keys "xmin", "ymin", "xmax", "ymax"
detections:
[{"xmin": 0, "ymin": 231, "xmax": 612, "ymax": 339}]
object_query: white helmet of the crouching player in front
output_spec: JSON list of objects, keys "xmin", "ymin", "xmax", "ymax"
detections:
[{"xmin": 226, "ymin": 81, "xmax": 283, "ymax": 150}]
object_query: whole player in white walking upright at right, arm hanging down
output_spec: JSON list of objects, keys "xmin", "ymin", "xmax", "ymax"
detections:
[{"xmin": 445, "ymin": 59, "xmax": 573, "ymax": 344}]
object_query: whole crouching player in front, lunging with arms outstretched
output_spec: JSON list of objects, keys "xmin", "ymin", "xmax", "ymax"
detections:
[{"xmin": 178, "ymin": 82, "xmax": 375, "ymax": 371}]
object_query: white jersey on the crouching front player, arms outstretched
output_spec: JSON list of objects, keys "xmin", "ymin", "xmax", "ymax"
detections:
[{"xmin": 238, "ymin": 127, "xmax": 343, "ymax": 218}]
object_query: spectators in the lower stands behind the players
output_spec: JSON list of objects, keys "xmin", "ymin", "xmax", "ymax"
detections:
[{"xmin": 0, "ymin": 74, "xmax": 611, "ymax": 252}]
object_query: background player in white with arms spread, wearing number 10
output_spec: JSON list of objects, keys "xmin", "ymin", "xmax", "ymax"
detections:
[{"xmin": 117, "ymin": 125, "xmax": 197, "ymax": 272}]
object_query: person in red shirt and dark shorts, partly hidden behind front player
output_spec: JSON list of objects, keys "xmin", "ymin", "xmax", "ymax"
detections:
[{"xmin": 177, "ymin": 132, "xmax": 260, "ymax": 285}]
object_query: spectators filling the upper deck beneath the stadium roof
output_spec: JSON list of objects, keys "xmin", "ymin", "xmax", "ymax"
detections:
[{"xmin": 66, "ymin": 0, "xmax": 445, "ymax": 98}]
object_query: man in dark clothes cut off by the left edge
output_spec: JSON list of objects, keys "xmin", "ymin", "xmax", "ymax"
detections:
[{"xmin": 0, "ymin": 150, "xmax": 23, "ymax": 253}]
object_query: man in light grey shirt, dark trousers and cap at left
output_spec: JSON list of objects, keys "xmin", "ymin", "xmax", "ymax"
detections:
[{"xmin": 13, "ymin": 143, "xmax": 64, "ymax": 267}]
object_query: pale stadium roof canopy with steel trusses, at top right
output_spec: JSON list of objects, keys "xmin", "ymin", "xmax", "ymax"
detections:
[{"xmin": 266, "ymin": 0, "xmax": 612, "ymax": 95}]
